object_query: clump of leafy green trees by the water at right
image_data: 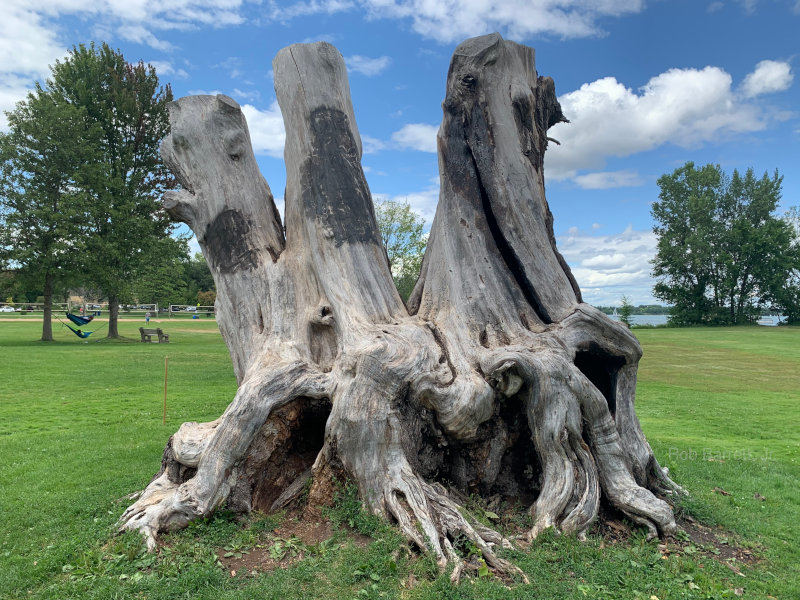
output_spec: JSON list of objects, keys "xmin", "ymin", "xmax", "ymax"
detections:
[{"xmin": 652, "ymin": 162, "xmax": 800, "ymax": 325}]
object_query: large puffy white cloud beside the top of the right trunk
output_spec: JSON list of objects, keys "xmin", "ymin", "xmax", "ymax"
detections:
[{"xmin": 545, "ymin": 66, "xmax": 775, "ymax": 179}]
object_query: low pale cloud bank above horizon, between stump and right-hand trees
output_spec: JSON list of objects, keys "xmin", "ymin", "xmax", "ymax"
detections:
[{"xmin": 556, "ymin": 226, "xmax": 657, "ymax": 306}]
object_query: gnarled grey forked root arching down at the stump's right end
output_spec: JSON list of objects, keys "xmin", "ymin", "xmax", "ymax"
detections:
[{"xmin": 482, "ymin": 346, "xmax": 676, "ymax": 539}]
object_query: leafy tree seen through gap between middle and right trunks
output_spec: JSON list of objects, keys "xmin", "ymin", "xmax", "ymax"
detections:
[{"xmin": 375, "ymin": 200, "xmax": 428, "ymax": 301}]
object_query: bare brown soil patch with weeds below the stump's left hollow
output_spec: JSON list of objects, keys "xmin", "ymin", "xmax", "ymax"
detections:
[{"xmin": 217, "ymin": 512, "xmax": 372, "ymax": 577}]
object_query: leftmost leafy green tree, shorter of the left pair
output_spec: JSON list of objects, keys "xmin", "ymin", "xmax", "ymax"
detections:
[{"xmin": 0, "ymin": 84, "xmax": 100, "ymax": 341}]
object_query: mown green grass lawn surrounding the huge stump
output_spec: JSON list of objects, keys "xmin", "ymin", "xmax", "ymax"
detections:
[{"xmin": 0, "ymin": 319, "xmax": 800, "ymax": 600}]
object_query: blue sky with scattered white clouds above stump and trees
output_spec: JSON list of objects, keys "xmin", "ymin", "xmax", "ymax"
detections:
[{"xmin": 0, "ymin": 0, "xmax": 800, "ymax": 304}]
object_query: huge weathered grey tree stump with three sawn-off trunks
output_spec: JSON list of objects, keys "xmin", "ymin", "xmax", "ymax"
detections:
[{"xmin": 121, "ymin": 34, "xmax": 679, "ymax": 577}]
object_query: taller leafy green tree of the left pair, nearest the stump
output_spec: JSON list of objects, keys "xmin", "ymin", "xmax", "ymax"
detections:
[{"xmin": 46, "ymin": 43, "xmax": 173, "ymax": 337}]
